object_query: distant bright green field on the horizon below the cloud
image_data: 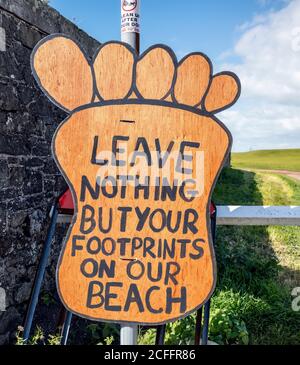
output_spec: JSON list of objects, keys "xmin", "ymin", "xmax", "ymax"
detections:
[{"xmin": 232, "ymin": 149, "xmax": 300, "ymax": 171}]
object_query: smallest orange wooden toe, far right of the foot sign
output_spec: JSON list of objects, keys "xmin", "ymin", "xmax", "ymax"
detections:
[{"xmin": 205, "ymin": 74, "xmax": 239, "ymax": 113}]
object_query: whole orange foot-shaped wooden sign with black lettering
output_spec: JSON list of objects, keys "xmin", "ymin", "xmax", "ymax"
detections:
[{"xmin": 32, "ymin": 35, "xmax": 240, "ymax": 324}]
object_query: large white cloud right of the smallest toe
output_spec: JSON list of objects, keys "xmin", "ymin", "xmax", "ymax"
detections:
[{"xmin": 220, "ymin": 0, "xmax": 300, "ymax": 151}]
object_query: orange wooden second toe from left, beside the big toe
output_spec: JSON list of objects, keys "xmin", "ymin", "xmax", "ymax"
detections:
[{"xmin": 94, "ymin": 43, "xmax": 134, "ymax": 100}]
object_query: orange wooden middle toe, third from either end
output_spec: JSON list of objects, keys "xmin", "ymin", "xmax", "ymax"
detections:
[{"xmin": 136, "ymin": 48, "xmax": 175, "ymax": 99}]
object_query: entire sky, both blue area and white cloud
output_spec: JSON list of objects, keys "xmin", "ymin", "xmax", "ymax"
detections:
[{"xmin": 50, "ymin": 0, "xmax": 300, "ymax": 152}]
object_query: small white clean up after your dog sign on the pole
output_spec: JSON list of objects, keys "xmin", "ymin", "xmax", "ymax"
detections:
[{"xmin": 121, "ymin": 0, "xmax": 140, "ymax": 33}]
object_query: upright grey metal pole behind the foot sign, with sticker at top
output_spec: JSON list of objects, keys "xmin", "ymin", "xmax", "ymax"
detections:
[{"xmin": 120, "ymin": 0, "xmax": 141, "ymax": 345}]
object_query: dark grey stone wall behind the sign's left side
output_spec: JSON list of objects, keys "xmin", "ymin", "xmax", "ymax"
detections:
[{"xmin": 0, "ymin": 0, "xmax": 99, "ymax": 344}]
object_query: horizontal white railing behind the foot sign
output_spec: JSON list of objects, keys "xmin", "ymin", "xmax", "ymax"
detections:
[{"xmin": 58, "ymin": 205, "xmax": 300, "ymax": 226}]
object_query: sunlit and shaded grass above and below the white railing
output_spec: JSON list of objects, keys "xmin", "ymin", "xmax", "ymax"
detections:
[{"xmin": 140, "ymin": 169, "xmax": 300, "ymax": 345}]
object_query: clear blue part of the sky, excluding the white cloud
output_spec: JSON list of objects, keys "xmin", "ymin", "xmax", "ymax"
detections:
[{"xmin": 50, "ymin": 0, "xmax": 283, "ymax": 62}]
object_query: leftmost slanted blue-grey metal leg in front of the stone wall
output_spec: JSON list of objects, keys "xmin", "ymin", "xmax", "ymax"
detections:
[{"xmin": 23, "ymin": 202, "xmax": 58, "ymax": 342}]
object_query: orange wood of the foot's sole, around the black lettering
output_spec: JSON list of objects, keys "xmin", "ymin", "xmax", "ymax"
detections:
[{"xmin": 55, "ymin": 105, "xmax": 229, "ymax": 324}]
